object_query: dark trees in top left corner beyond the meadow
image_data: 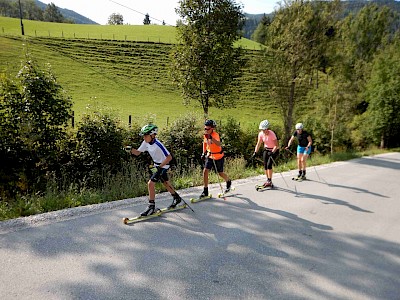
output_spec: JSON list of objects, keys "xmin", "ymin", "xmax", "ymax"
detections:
[{"xmin": 0, "ymin": 0, "xmax": 74, "ymax": 23}]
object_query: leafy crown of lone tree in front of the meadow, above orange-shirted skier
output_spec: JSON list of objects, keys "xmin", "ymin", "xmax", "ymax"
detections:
[{"xmin": 172, "ymin": 0, "xmax": 245, "ymax": 116}]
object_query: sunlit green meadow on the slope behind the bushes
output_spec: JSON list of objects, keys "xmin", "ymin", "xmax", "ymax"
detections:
[{"xmin": 0, "ymin": 17, "xmax": 279, "ymax": 127}]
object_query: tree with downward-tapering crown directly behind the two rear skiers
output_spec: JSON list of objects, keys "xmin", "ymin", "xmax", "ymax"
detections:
[{"xmin": 260, "ymin": 0, "xmax": 338, "ymax": 141}]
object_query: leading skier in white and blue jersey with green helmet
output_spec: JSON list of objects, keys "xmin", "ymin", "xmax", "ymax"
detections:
[{"xmin": 130, "ymin": 124, "xmax": 182, "ymax": 216}]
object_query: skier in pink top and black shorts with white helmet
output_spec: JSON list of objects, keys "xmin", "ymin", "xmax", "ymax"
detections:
[{"xmin": 253, "ymin": 120, "xmax": 279, "ymax": 188}]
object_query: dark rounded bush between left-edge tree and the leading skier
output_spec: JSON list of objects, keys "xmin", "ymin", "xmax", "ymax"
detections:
[{"xmin": 58, "ymin": 111, "xmax": 127, "ymax": 188}]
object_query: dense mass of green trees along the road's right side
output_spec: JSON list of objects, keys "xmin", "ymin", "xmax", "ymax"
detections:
[{"xmin": 254, "ymin": 0, "xmax": 400, "ymax": 152}]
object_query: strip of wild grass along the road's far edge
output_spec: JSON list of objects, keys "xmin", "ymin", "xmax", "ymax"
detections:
[{"xmin": 0, "ymin": 148, "xmax": 400, "ymax": 221}]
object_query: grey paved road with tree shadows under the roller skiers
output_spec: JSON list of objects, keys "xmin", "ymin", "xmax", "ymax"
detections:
[{"xmin": 0, "ymin": 153, "xmax": 400, "ymax": 299}]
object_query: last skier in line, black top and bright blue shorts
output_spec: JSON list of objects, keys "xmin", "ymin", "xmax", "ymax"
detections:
[{"xmin": 285, "ymin": 123, "xmax": 312, "ymax": 179}]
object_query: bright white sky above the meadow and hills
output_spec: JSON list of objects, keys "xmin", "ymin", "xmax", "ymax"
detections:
[{"xmin": 40, "ymin": 0, "xmax": 278, "ymax": 25}]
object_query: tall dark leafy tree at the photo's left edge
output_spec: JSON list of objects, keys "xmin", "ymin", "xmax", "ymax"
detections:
[{"xmin": 0, "ymin": 58, "xmax": 72, "ymax": 195}]
